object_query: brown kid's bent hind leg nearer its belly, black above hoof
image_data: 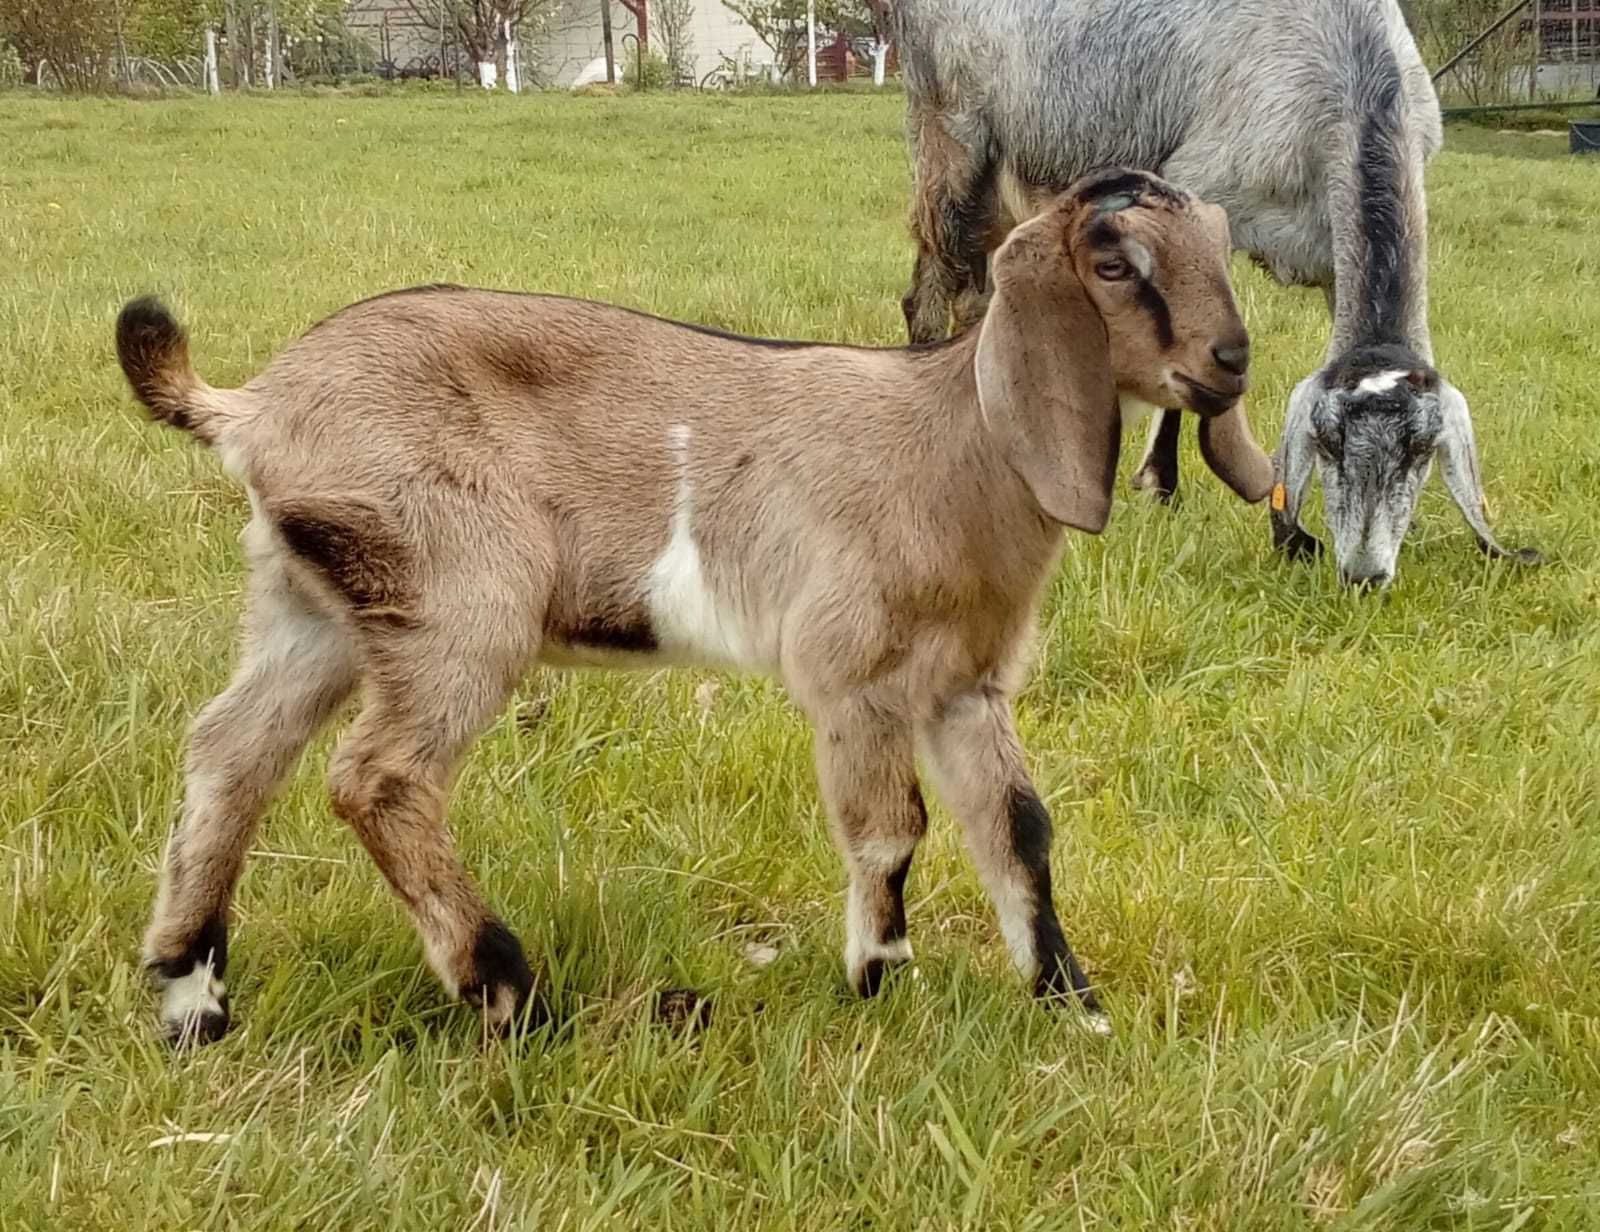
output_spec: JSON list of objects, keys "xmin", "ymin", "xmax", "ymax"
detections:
[{"xmin": 330, "ymin": 611, "xmax": 544, "ymax": 1029}]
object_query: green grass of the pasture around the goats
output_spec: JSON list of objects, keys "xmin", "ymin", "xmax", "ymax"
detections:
[{"xmin": 0, "ymin": 94, "xmax": 1600, "ymax": 1232}]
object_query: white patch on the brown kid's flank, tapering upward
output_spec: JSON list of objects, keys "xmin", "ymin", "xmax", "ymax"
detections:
[{"xmin": 645, "ymin": 424, "xmax": 757, "ymax": 667}]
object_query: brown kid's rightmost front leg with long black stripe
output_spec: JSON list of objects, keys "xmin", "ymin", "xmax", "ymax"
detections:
[{"xmin": 918, "ymin": 688, "xmax": 1110, "ymax": 1034}]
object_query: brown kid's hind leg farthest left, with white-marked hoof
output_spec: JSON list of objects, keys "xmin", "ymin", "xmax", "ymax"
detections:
[{"xmin": 144, "ymin": 544, "xmax": 355, "ymax": 1042}]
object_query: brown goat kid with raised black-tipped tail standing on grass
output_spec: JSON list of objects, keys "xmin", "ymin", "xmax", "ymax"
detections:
[{"xmin": 117, "ymin": 171, "xmax": 1267, "ymax": 1040}]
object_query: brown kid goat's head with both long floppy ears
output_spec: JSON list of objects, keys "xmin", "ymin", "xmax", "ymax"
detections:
[{"xmin": 976, "ymin": 168, "xmax": 1272, "ymax": 531}]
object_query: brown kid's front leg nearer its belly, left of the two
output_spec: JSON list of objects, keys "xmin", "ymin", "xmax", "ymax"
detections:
[{"xmin": 816, "ymin": 702, "xmax": 928, "ymax": 997}]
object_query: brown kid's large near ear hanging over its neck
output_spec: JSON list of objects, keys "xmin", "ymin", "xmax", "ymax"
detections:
[{"xmin": 974, "ymin": 208, "xmax": 1122, "ymax": 534}]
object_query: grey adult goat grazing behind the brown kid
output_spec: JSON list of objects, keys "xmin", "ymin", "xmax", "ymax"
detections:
[{"xmin": 893, "ymin": 0, "xmax": 1538, "ymax": 584}]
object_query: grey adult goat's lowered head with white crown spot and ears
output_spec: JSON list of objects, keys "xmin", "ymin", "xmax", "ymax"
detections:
[{"xmin": 1272, "ymin": 336, "xmax": 1539, "ymax": 587}]
